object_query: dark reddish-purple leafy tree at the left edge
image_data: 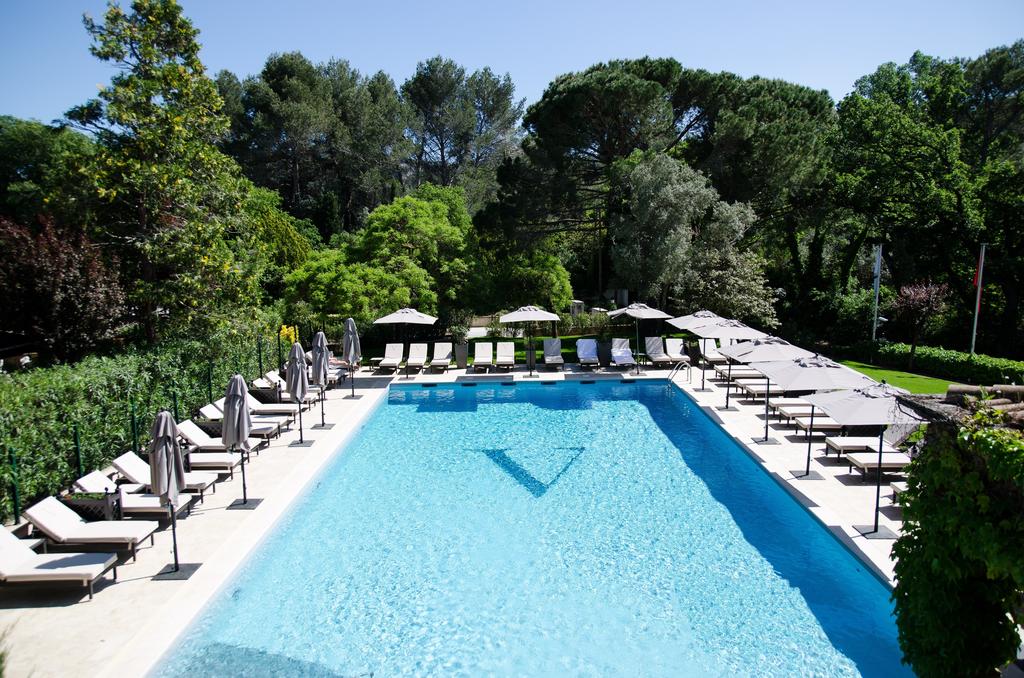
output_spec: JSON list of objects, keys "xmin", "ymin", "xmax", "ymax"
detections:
[{"xmin": 0, "ymin": 217, "xmax": 125, "ymax": 359}]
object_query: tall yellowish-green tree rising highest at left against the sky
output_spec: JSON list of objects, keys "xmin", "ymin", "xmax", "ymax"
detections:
[{"xmin": 68, "ymin": 0, "xmax": 261, "ymax": 341}]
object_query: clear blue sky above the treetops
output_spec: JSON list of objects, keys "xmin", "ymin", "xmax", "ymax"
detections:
[{"xmin": 0, "ymin": 0, "xmax": 1024, "ymax": 122}]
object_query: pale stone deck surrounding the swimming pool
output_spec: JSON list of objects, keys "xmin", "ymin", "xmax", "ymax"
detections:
[{"xmin": 0, "ymin": 366, "xmax": 900, "ymax": 676}]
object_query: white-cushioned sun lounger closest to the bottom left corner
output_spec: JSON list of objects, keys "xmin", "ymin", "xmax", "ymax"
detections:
[{"xmin": 0, "ymin": 528, "xmax": 118, "ymax": 598}]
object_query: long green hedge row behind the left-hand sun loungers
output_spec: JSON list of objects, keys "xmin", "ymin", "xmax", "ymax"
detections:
[{"xmin": 0, "ymin": 327, "xmax": 287, "ymax": 519}]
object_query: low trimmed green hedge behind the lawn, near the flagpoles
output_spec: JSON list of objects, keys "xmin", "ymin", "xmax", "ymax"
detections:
[{"xmin": 873, "ymin": 344, "xmax": 1024, "ymax": 385}]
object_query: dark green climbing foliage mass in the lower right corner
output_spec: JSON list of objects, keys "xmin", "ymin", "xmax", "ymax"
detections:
[{"xmin": 893, "ymin": 415, "xmax": 1024, "ymax": 677}]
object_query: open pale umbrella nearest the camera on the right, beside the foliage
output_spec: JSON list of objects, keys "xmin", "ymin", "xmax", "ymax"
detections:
[{"xmin": 804, "ymin": 382, "xmax": 925, "ymax": 535}]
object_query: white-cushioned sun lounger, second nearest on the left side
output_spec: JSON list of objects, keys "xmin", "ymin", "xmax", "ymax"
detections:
[{"xmin": 25, "ymin": 497, "xmax": 160, "ymax": 560}]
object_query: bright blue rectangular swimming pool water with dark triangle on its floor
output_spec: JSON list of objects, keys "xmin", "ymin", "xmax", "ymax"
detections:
[{"xmin": 157, "ymin": 381, "xmax": 908, "ymax": 676}]
